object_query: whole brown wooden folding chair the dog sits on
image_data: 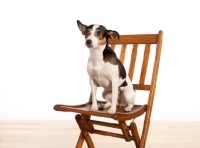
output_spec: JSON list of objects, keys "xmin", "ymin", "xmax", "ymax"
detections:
[{"xmin": 54, "ymin": 31, "xmax": 163, "ymax": 148}]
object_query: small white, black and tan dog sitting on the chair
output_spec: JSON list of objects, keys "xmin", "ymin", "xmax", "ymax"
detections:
[{"xmin": 77, "ymin": 20, "xmax": 136, "ymax": 114}]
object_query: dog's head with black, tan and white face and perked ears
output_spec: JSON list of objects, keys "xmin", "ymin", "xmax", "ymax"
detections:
[{"xmin": 77, "ymin": 20, "xmax": 119, "ymax": 49}]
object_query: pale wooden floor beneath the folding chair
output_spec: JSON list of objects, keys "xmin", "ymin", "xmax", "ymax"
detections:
[{"xmin": 0, "ymin": 121, "xmax": 200, "ymax": 148}]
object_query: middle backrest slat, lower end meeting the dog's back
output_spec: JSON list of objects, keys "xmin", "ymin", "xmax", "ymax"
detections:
[{"xmin": 128, "ymin": 44, "xmax": 138, "ymax": 81}]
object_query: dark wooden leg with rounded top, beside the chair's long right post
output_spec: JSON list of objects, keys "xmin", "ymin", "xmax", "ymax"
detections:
[{"xmin": 130, "ymin": 122, "xmax": 141, "ymax": 148}]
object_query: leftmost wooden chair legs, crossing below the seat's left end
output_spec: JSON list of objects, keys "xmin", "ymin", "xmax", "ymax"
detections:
[{"xmin": 75, "ymin": 114, "xmax": 94, "ymax": 148}]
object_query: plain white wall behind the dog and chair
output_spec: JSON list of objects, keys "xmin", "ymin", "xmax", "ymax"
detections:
[{"xmin": 0, "ymin": 0, "xmax": 200, "ymax": 121}]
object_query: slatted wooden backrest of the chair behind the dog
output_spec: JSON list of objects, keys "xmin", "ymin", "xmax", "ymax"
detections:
[{"xmin": 109, "ymin": 31, "xmax": 163, "ymax": 106}]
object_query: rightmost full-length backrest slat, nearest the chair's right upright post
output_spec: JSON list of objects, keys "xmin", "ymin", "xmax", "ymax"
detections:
[{"xmin": 139, "ymin": 44, "xmax": 151, "ymax": 84}]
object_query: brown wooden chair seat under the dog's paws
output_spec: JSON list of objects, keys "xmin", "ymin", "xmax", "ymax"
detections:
[{"xmin": 54, "ymin": 101, "xmax": 147, "ymax": 121}]
